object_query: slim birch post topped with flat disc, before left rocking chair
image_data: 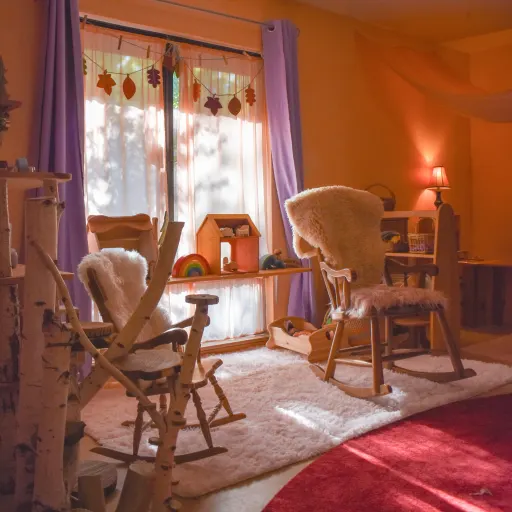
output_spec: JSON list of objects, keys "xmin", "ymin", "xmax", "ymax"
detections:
[{"xmin": 151, "ymin": 295, "xmax": 219, "ymax": 512}]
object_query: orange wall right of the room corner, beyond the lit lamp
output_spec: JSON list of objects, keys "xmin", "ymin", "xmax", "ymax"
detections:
[{"xmin": 471, "ymin": 41, "xmax": 512, "ymax": 261}]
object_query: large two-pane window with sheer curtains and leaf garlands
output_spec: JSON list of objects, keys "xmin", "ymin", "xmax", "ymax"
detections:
[{"xmin": 85, "ymin": 29, "xmax": 270, "ymax": 340}]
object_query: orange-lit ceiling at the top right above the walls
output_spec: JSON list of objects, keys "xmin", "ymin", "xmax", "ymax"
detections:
[{"xmin": 296, "ymin": 0, "xmax": 512, "ymax": 42}]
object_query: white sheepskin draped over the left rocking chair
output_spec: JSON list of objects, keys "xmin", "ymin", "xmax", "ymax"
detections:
[{"xmin": 78, "ymin": 249, "xmax": 172, "ymax": 342}]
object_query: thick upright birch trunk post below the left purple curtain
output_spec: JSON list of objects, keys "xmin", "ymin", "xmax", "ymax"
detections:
[{"xmin": 15, "ymin": 197, "xmax": 57, "ymax": 512}]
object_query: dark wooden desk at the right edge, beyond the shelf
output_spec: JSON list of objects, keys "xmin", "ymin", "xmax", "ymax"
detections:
[{"xmin": 459, "ymin": 260, "xmax": 512, "ymax": 328}]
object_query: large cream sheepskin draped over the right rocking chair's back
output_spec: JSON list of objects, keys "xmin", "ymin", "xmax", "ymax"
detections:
[{"xmin": 285, "ymin": 186, "xmax": 385, "ymax": 288}]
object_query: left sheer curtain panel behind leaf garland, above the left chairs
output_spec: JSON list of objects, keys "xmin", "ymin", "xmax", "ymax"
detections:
[{"xmin": 83, "ymin": 25, "xmax": 167, "ymax": 220}]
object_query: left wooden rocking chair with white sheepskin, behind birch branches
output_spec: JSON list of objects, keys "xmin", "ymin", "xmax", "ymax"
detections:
[{"xmin": 79, "ymin": 249, "xmax": 246, "ymax": 464}]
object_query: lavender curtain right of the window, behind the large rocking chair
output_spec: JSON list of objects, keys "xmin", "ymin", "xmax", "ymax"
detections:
[{"xmin": 263, "ymin": 20, "xmax": 314, "ymax": 321}]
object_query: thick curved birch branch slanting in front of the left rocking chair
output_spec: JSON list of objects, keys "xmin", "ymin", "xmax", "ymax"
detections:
[{"xmin": 80, "ymin": 222, "xmax": 184, "ymax": 407}]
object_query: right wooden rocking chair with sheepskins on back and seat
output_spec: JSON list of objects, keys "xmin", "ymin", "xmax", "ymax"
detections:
[{"xmin": 285, "ymin": 186, "xmax": 475, "ymax": 398}]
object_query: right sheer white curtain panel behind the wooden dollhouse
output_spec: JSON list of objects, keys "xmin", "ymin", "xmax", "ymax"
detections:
[{"xmin": 166, "ymin": 45, "xmax": 270, "ymax": 339}]
